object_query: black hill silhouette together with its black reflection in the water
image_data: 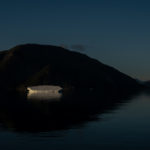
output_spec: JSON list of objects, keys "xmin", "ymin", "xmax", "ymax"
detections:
[{"xmin": 0, "ymin": 44, "xmax": 143, "ymax": 132}]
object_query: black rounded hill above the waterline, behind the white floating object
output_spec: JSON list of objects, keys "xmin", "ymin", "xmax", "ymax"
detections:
[{"xmin": 0, "ymin": 44, "xmax": 140, "ymax": 92}]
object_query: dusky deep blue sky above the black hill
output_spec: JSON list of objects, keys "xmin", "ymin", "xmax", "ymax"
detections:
[{"xmin": 0, "ymin": 0, "xmax": 150, "ymax": 80}]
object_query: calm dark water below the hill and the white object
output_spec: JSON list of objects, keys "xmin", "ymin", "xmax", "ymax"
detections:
[{"xmin": 0, "ymin": 93, "xmax": 150, "ymax": 150}]
